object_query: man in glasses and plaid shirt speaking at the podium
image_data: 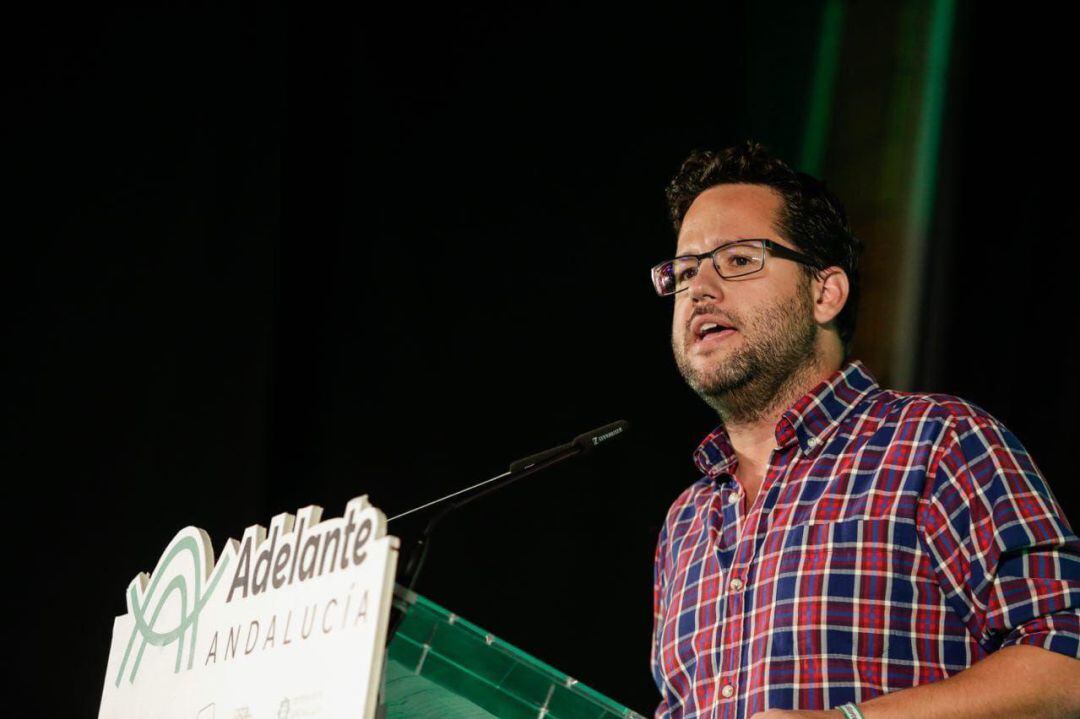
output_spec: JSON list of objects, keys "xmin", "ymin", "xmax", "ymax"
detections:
[{"xmin": 652, "ymin": 144, "xmax": 1080, "ymax": 719}]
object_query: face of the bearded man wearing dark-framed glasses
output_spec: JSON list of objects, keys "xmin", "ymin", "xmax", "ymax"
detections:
[{"xmin": 672, "ymin": 185, "xmax": 818, "ymax": 408}]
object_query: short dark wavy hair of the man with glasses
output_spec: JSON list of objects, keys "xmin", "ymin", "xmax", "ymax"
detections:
[{"xmin": 665, "ymin": 141, "xmax": 863, "ymax": 350}]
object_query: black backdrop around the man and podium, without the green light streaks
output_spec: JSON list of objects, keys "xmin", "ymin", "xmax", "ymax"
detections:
[{"xmin": 2, "ymin": 2, "xmax": 1080, "ymax": 716}]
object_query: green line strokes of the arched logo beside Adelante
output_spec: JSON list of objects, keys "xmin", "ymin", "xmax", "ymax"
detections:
[{"xmin": 116, "ymin": 530, "xmax": 229, "ymax": 687}]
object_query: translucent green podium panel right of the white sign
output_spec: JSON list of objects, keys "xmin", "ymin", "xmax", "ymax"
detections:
[{"xmin": 380, "ymin": 586, "xmax": 643, "ymax": 719}]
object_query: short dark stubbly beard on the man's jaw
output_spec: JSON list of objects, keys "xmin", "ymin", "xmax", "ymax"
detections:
[{"xmin": 672, "ymin": 285, "xmax": 819, "ymax": 423}]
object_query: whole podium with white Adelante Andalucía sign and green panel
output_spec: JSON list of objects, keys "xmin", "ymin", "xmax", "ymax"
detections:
[{"xmin": 98, "ymin": 497, "xmax": 642, "ymax": 719}]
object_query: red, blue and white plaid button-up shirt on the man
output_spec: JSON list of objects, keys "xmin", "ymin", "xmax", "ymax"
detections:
[{"xmin": 652, "ymin": 362, "xmax": 1080, "ymax": 719}]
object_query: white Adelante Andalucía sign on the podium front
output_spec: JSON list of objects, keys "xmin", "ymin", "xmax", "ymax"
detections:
[{"xmin": 98, "ymin": 497, "xmax": 397, "ymax": 719}]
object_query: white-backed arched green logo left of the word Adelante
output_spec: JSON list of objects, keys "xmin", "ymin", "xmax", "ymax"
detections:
[{"xmin": 114, "ymin": 527, "xmax": 229, "ymax": 687}]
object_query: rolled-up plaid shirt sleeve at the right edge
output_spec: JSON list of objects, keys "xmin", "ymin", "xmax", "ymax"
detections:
[{"xmin": 918, "ymin": 416, "xmax": 1080, "ymax": 657}]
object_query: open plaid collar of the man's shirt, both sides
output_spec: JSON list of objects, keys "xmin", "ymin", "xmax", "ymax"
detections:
[{"xmin": 693, "ymin": 360, "xmax": 878, "ymax": 478}]
